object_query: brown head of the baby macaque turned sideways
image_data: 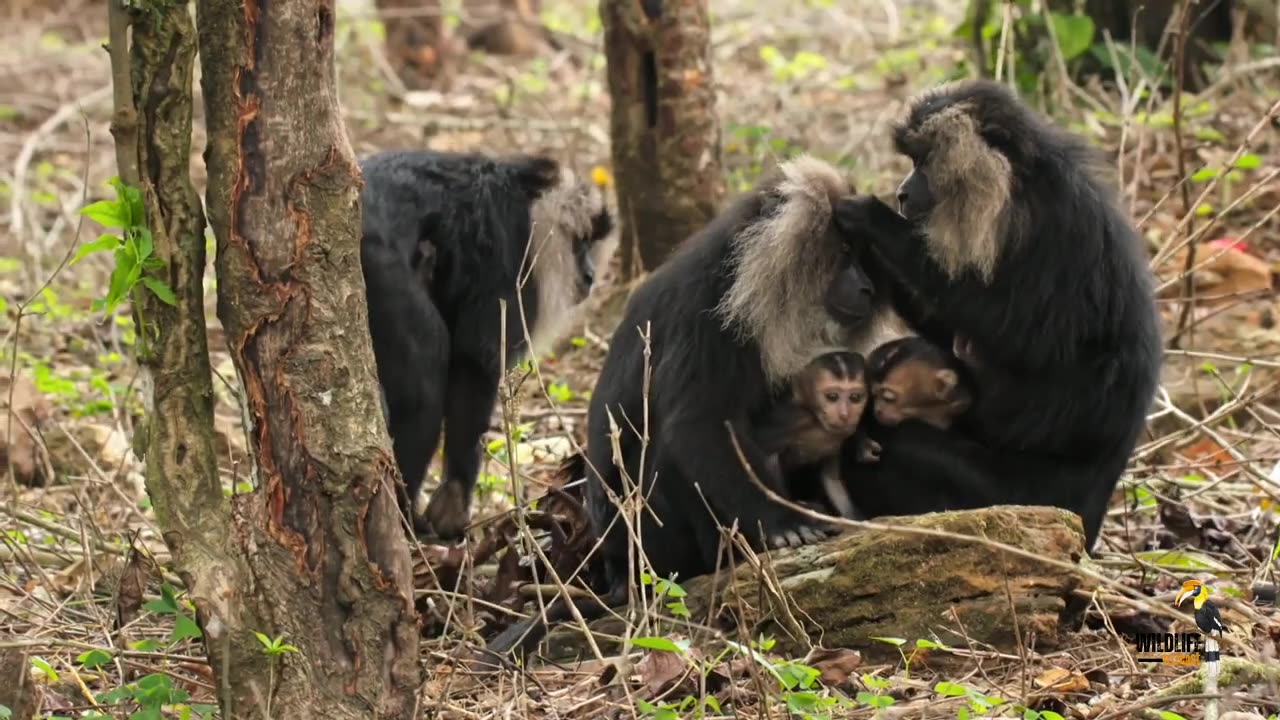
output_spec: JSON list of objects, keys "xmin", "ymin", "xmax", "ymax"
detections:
[{"xmin": 867, "ymin": 337, "xmax": 974, "ymax": 430}]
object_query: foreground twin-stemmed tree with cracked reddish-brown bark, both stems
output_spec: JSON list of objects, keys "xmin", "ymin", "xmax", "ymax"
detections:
[{"xmin": 96, "ymin": 0, "xmax": 419, "ymax": 719}]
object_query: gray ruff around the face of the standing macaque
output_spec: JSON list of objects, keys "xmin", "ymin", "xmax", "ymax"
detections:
[{"xmin": 521, "ymin": 168, "xmax": 617, "ymax": 357}]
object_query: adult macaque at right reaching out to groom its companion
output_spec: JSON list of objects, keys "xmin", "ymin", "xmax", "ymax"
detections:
[{"xmin": 836, "ymin": 81, "xmax": 1161, "ymax": 547}]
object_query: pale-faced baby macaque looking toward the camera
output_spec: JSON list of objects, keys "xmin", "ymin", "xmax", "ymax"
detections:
[{"xmin": 758, "ymin": 351, "xmax": 879, "ymax": 518}]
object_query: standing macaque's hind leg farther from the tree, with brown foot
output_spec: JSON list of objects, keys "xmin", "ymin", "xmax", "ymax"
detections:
[{"xmin": 426, "ymin": 355, "xmax": 498, "ymax": 539}]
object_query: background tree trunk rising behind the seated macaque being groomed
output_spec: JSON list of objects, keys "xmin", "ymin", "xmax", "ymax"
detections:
[{"xmin": 600, "ymin": 0, "xmax": 724, "ymax": 278}]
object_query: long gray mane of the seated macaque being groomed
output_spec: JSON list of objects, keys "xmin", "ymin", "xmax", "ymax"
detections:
[{"xmin": 716, "ymin": 155, "xmax": 909, "ymax": 387}]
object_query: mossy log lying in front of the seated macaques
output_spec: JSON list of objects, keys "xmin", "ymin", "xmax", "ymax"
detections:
[{"xmin": 548, "ymin": 506, "xmax": 1085, "ymax": 660}]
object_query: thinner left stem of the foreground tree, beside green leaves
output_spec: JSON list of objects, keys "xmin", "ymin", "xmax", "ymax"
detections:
[{"xmin": 108, "ymin": 0, "xmax": 268, "ymax": 717}]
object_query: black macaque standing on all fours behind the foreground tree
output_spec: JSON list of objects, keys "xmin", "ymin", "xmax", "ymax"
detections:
[{"xmin": 361, "ymin": 150, "xmax": 613, "ymax": 539}]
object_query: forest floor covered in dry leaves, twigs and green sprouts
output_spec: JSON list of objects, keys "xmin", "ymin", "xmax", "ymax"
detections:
[{"xmin": 0, "ymin": 0, "xmax": 1280, "ymax": 719}]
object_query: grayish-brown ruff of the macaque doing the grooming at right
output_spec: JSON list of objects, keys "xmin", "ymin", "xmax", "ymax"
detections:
[{"xmin": 890, "ymin": 98, "xmax": 1012, "ymax": 283}]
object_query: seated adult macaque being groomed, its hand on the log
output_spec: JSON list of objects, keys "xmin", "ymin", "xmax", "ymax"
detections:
[{"xmin": 488, "ymin": 158, "xmax": 887, "ymax": 652}]
